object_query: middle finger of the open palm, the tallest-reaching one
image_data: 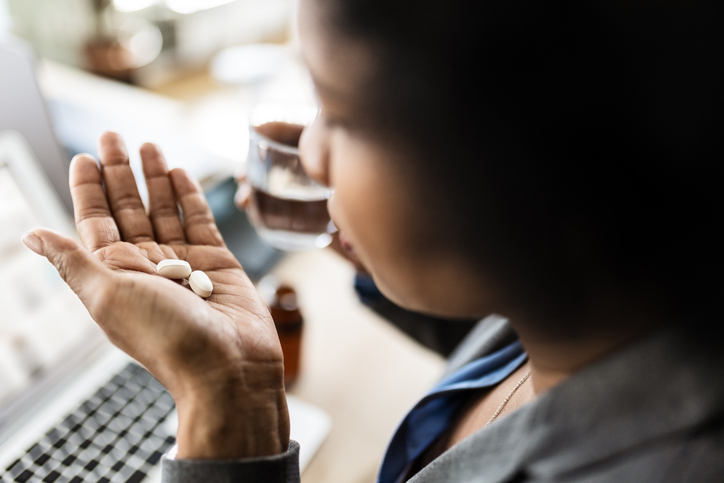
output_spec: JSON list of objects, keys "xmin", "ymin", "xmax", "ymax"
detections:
[{"xmin": 99, "ymin": 132, "xmax": 154, "ymax": 243}]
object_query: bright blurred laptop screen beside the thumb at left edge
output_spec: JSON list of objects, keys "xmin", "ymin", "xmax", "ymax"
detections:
[{"xmin": 0, "ymin": 162, "xmax": 98, "ymax": 420}]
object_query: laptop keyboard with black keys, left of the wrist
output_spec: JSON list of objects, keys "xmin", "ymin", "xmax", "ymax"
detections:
[{"xmin": 0, "ymin": 364, "xmax": 175, "ymax": 483}]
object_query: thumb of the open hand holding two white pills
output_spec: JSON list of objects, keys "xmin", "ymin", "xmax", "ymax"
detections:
[{"xmin": 22, "ymin": 228, "xmax": 110, "ymax": 308}]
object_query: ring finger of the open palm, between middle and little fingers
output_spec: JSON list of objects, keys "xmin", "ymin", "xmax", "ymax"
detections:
[{"xmin": 141, "ymin": 143, "xmax": 186, "ymax": 245}]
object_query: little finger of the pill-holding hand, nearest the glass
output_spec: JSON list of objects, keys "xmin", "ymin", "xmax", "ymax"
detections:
[{"xmin": 169, "ymin": 169, "xmax": 226, "ymax": 247}]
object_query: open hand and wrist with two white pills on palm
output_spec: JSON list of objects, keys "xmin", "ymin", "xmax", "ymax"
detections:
[{"xmin": 23, "ymin": 133, "xmax": 289, "ymax": 459}]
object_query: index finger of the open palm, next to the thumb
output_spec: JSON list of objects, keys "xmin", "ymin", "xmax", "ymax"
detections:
[{"xmin": 70, "ymin": 154, "xmax": 121, "ymax": 252}]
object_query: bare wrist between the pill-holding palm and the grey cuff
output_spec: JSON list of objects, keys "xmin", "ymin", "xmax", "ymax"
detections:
[{"xmin": 176, "ymin": 364, "xmax": 289, "ymax": 459}]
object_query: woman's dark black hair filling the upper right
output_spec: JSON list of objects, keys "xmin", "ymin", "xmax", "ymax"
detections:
[{"xmin": 318, "ymin": 0, "xmax": 724, "ymax": 336}]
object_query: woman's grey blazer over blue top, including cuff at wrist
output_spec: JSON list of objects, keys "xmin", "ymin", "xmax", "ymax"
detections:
[{"xmin": 163, "ymin": 316, "xmax": 724, "ymax": 483}]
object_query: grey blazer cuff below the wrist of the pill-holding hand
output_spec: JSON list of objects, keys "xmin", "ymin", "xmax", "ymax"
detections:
[{"xmin": 162, "ymin": 441, "xmax": 300, "ymax": 483}]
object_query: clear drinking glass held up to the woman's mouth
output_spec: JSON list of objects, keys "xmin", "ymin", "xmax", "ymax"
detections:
[{"xmin": 246, "ymin": 103, "xmax": 337, "ymax": 251}]
